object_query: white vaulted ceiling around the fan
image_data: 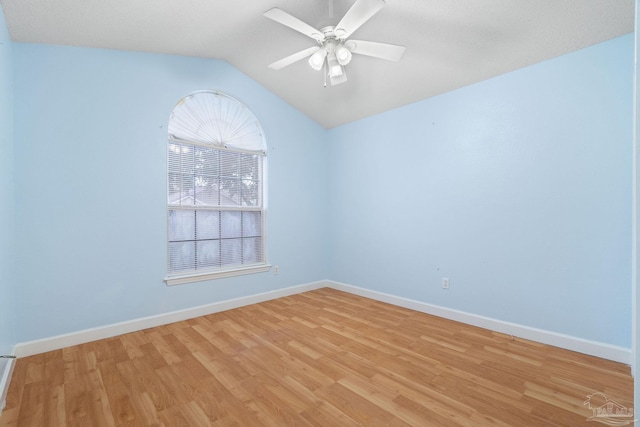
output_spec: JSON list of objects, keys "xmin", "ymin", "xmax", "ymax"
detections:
[{"xmin": 0, "ymin": 0, "xmax": 634, "ymax": 128}]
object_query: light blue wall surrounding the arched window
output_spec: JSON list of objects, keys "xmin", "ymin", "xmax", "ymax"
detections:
[{"xmin": 13, "ymin": 43, "xmax": 327, "ymax": 342}]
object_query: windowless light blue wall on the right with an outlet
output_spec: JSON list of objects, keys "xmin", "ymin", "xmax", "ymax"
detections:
[{"xmin": 329, "ymin": 35, "xmax": 634, "ymax": 348}]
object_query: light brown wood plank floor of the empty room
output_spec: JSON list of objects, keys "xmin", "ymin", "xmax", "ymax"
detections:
[{"xmin": 0, "ymin": 289, "xmax": 633, "ymax": 427}]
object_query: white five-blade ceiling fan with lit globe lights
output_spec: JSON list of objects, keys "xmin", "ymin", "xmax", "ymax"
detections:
[{"xmin": 264, "ymin": 0, "xmax": 406, "ymax": 86}]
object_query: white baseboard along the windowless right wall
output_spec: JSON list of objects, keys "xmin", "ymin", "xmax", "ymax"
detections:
[{"xmin": 326, "ymin": 281, "xmax": 632, "ymax": 365}]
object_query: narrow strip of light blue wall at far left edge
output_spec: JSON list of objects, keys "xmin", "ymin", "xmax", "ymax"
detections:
[{"xmin": 0, "ymin": 4, "xmax": 16, "ymax": 364}]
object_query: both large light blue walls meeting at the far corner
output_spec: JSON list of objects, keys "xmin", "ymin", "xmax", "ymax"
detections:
[{"xmin": 8, "ymin": 29, "xmax": 633, "ymax": 354}]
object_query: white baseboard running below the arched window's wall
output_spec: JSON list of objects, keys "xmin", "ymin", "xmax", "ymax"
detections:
[{"xmin": 14, "ymin": 282, "xmax": 328, "ymax": 357}]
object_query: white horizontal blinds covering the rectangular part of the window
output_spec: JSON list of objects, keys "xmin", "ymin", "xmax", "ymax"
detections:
[{"xmin": 168, "ymin": 143, "xmax": 264, "ymax": 273}]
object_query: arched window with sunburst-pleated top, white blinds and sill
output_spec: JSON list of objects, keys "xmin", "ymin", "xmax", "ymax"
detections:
[{"xmin": 166, "ymin": 91, "xmax": 270, "ymax": 285}]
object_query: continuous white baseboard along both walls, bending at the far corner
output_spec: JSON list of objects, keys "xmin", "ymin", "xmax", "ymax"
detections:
[{"xmin": 15, "ymin": 281, "xmax": 632, "ymax": 365}]
